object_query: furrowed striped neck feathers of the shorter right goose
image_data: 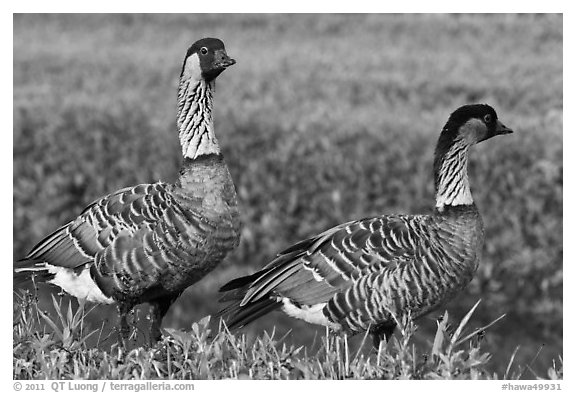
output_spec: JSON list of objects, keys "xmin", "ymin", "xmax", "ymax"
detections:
[{"xmin": 434, "ymin": 136, "xmax": 474, "ymax": 212}]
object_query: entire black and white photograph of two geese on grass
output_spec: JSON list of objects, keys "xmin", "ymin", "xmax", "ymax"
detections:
[{"xmin": 12, "ymin": 12, "xmax": 565, "ymax": 382}]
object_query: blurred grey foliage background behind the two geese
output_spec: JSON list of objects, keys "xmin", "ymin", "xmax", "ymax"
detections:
[{"xmin": 13, "ymin": 14, "xmax": 563, "ymax": 374}]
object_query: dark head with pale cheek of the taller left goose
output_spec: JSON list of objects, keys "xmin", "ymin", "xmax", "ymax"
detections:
[{"xmin": 180, "ymin": 38, "xmax": 236, "ymax": 82}]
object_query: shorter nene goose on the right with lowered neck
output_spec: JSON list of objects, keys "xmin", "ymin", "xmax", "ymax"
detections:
[{"xmin": 220, "ymin": 105, "xmax": 512, "ymax": 346}]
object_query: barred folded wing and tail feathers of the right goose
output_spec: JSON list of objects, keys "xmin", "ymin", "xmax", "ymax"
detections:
[{"xmin": 221, "ymin": 216, "xmax": 430, "ymax": 327}]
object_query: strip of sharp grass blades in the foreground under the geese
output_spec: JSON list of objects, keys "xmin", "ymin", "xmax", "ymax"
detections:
[{"xmin": 14, "ymin": 293, "xmax": 563, "ymax": 380}]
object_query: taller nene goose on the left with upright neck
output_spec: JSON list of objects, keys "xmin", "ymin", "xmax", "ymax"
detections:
[{"xmin": 14, "ymin": 38, "xmax": 240, "ymax": 344}]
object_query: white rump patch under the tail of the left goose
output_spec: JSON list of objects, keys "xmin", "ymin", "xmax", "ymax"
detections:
[{"xmin": 46, "ymin": 264, "xmax": 114, "ymax": 304}]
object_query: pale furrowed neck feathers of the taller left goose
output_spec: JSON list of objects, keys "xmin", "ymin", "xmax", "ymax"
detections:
[{"xmin": 176, "ymin": 77, "xmax": 220, "ymax": 160}]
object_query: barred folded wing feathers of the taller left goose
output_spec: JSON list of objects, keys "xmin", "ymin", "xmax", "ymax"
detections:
[{"xmin": 16, "ymin": 183, "xmax": 202, "ymax": 296}]
